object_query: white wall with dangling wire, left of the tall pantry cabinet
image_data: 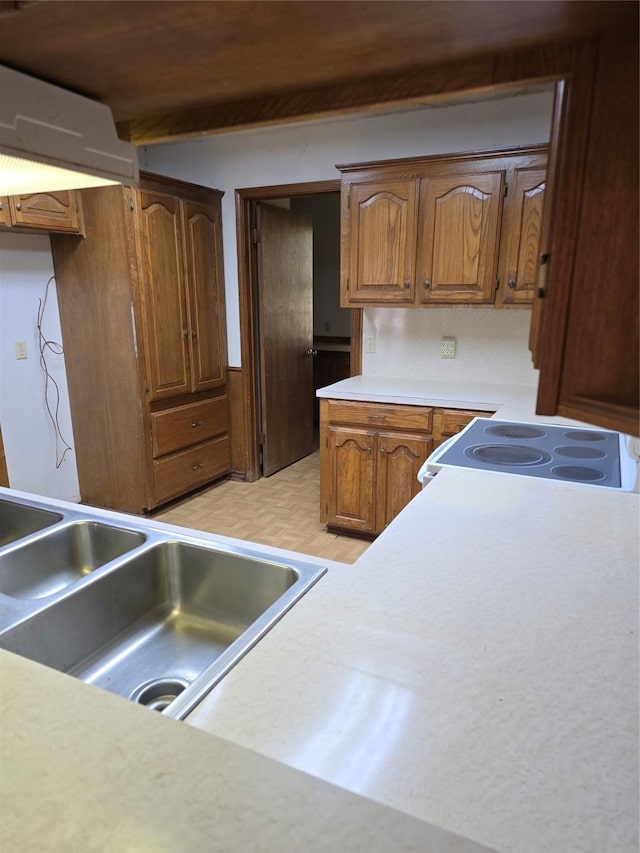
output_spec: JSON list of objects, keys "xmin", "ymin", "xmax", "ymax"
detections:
[{"xmin": 0, "ymin": 233, "xmax": 80, "ymax": 501}]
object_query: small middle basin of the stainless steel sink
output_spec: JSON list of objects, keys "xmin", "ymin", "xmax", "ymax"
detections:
[{"xmin": 0, "ymin": 520, "xmax": 146, "ymax": 598}]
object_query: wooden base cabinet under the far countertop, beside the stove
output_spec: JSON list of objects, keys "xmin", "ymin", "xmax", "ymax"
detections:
[{"xmin": 320, "ymin": 399, "xmax": 493, "ymax": 536}]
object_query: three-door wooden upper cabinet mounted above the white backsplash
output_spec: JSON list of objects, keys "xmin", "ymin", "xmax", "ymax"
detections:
[{"xmin": 338, "ymin": 146, "xmax": 547, "ymax": 307}]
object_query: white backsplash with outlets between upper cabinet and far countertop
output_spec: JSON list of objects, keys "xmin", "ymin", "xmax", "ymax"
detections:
[{"xmin": 362, "ymin": 306, "xmax": 538, "ymax": 385}]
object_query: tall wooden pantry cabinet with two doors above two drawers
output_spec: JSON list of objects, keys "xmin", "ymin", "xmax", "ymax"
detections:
[{"xmin": 51, "ymin": 174, "xmax": 230, "ymax": 513}]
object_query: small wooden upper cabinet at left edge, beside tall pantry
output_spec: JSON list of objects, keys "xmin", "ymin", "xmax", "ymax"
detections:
[{"xmin": 0, "ymin": 190, "xmax": 82, "ymax": 234}]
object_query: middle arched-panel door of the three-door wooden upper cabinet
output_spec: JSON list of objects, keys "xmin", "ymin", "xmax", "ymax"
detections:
[{"xmin": 418, "ymin": 172, "xmax": 503, "ymax": 303}]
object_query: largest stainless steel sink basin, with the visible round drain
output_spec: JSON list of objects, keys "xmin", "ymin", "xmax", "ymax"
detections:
[{"xmin": 0, "ymin": 540, "xmax": 325, "ymax": 718}]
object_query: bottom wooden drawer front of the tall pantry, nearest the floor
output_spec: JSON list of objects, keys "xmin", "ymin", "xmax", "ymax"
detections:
[{"xmin": 153, "ymin": 435, "xmax": 231, "ymax": 503}]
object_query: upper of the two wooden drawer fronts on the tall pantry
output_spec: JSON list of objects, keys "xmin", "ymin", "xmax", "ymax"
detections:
[{"xmin": 151, "ymin": 395, "xmax": 229, "ymax": 456}]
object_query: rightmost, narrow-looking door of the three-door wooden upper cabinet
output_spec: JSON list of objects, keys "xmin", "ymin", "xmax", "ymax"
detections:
[{"xmin": 502, "ymin": 169, "xmax": 546, "ymax": 303}]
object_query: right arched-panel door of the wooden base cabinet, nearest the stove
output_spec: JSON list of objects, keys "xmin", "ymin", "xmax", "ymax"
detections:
[{"xmin": 376, "ymin": 432, "xmax": 433, "ymax": 533}]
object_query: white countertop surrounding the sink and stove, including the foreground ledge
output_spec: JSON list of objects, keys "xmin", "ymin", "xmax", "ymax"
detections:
[{"xmin": 0, "ymin": 377, "xmax": 640, "ymax": 853}]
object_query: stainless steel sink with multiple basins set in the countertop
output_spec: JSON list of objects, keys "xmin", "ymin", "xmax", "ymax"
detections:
[{"xmin": 0, "ymin": 492, "xmax": 326, "ymax": 719}]
